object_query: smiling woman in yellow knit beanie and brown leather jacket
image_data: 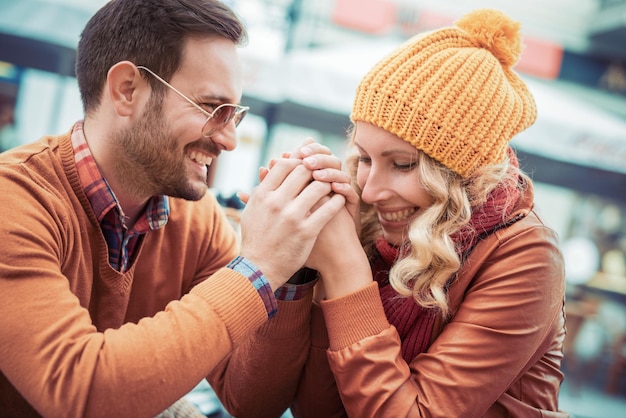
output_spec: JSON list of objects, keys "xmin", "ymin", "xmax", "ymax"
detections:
[{"xmin": 210, "ymin": 10, "xmax": 567, "ymax": 417}]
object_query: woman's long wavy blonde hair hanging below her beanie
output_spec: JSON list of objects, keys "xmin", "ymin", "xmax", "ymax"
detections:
[{"xmin": 346, "ymin": 129, "xmax": 529, "ymax": 317}]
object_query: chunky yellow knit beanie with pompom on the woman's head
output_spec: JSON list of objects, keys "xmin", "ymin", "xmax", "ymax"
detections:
[{"xmin": 351, "ymin": 9, "xmax": 537, "ymax": 177}]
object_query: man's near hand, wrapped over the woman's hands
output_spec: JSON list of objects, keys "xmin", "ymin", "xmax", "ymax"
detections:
[{"xmin": 241, "ymin": 158, "xmax": 346, "ymax": 290}]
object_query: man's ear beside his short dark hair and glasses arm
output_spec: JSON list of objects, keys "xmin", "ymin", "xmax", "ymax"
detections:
[{"xmin": 107, "ymin": 61, "xmax": 151, "ymax": 116}]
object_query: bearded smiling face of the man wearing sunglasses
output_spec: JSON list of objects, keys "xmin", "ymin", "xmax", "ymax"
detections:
[{"xmin": 115, "ymin": 39, "xmax": 242, "ymax": 200}]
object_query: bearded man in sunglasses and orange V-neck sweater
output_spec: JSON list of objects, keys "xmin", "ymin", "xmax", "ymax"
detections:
[{"xmin": 0, "ymin": 0, "xmax": 345, "ymax": 417}]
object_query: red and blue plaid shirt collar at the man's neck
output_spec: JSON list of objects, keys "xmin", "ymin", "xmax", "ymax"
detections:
[{"xmin": 72, "ymin": 121, "xmax": 170, "ymax": 234}]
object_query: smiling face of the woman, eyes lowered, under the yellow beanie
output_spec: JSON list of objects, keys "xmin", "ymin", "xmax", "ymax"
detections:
[{"xmin": 354, "ymin": 122, "xmax": 434, "ymax": 245}]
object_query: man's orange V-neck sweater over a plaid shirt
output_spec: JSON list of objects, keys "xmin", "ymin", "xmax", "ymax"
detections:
[{"xmin": 0, "ymin": 133, "xmax": 267, "ymax": 417}]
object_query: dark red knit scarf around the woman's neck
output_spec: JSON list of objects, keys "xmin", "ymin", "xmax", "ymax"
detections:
[{"xmin": 372, "ymin": 148, "xmax": 520, "ymax": 363}]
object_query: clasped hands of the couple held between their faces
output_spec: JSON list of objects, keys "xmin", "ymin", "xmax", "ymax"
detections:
[{"xmin": 236, "ymin": 139, "xmax": 371, "ymax": 296}]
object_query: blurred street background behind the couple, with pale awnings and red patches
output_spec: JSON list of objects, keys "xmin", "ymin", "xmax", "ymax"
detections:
[{"xmin": 0, "ymin": 0, "xmax": 626, "ymax": 418}]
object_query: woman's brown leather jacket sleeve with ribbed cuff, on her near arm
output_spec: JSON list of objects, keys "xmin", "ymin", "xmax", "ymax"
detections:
[{"xmin": 322, "ymin": 227, "xmax": 563, "ymax": 417}]
